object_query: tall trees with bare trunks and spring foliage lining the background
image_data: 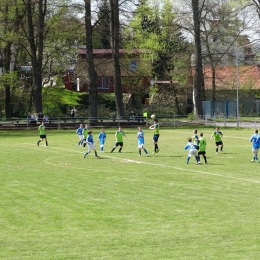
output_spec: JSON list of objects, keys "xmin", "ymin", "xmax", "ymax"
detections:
[{"xmin": 0, "ymin": 0, "xmax": 260, "ymax": 118}]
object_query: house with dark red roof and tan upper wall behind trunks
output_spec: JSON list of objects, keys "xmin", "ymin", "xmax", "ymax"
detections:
[{"xmin": 64, "ymin": 48, "xmax": 150, "ymax": 93}]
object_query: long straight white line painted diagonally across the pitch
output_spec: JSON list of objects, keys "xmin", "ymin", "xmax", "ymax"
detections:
[{"xmin": 24, "ymin": 143, "xmax": 260, "ymax": 184}]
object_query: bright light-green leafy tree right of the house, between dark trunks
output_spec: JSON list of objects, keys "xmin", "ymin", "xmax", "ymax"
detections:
[{"xmin": 124, "ymin": 0, "xmax": 189, "ymax": 114}]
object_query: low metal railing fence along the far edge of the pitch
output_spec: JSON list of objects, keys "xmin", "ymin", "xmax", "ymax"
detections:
[{"xmin": 0, "ymin": 115, "xmax": 260, "ymax": 130}]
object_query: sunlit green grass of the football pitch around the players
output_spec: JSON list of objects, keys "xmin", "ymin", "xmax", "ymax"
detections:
[{"xmin": 0, "ymin": 128, "xmax": 260, "ymax": 260}]
